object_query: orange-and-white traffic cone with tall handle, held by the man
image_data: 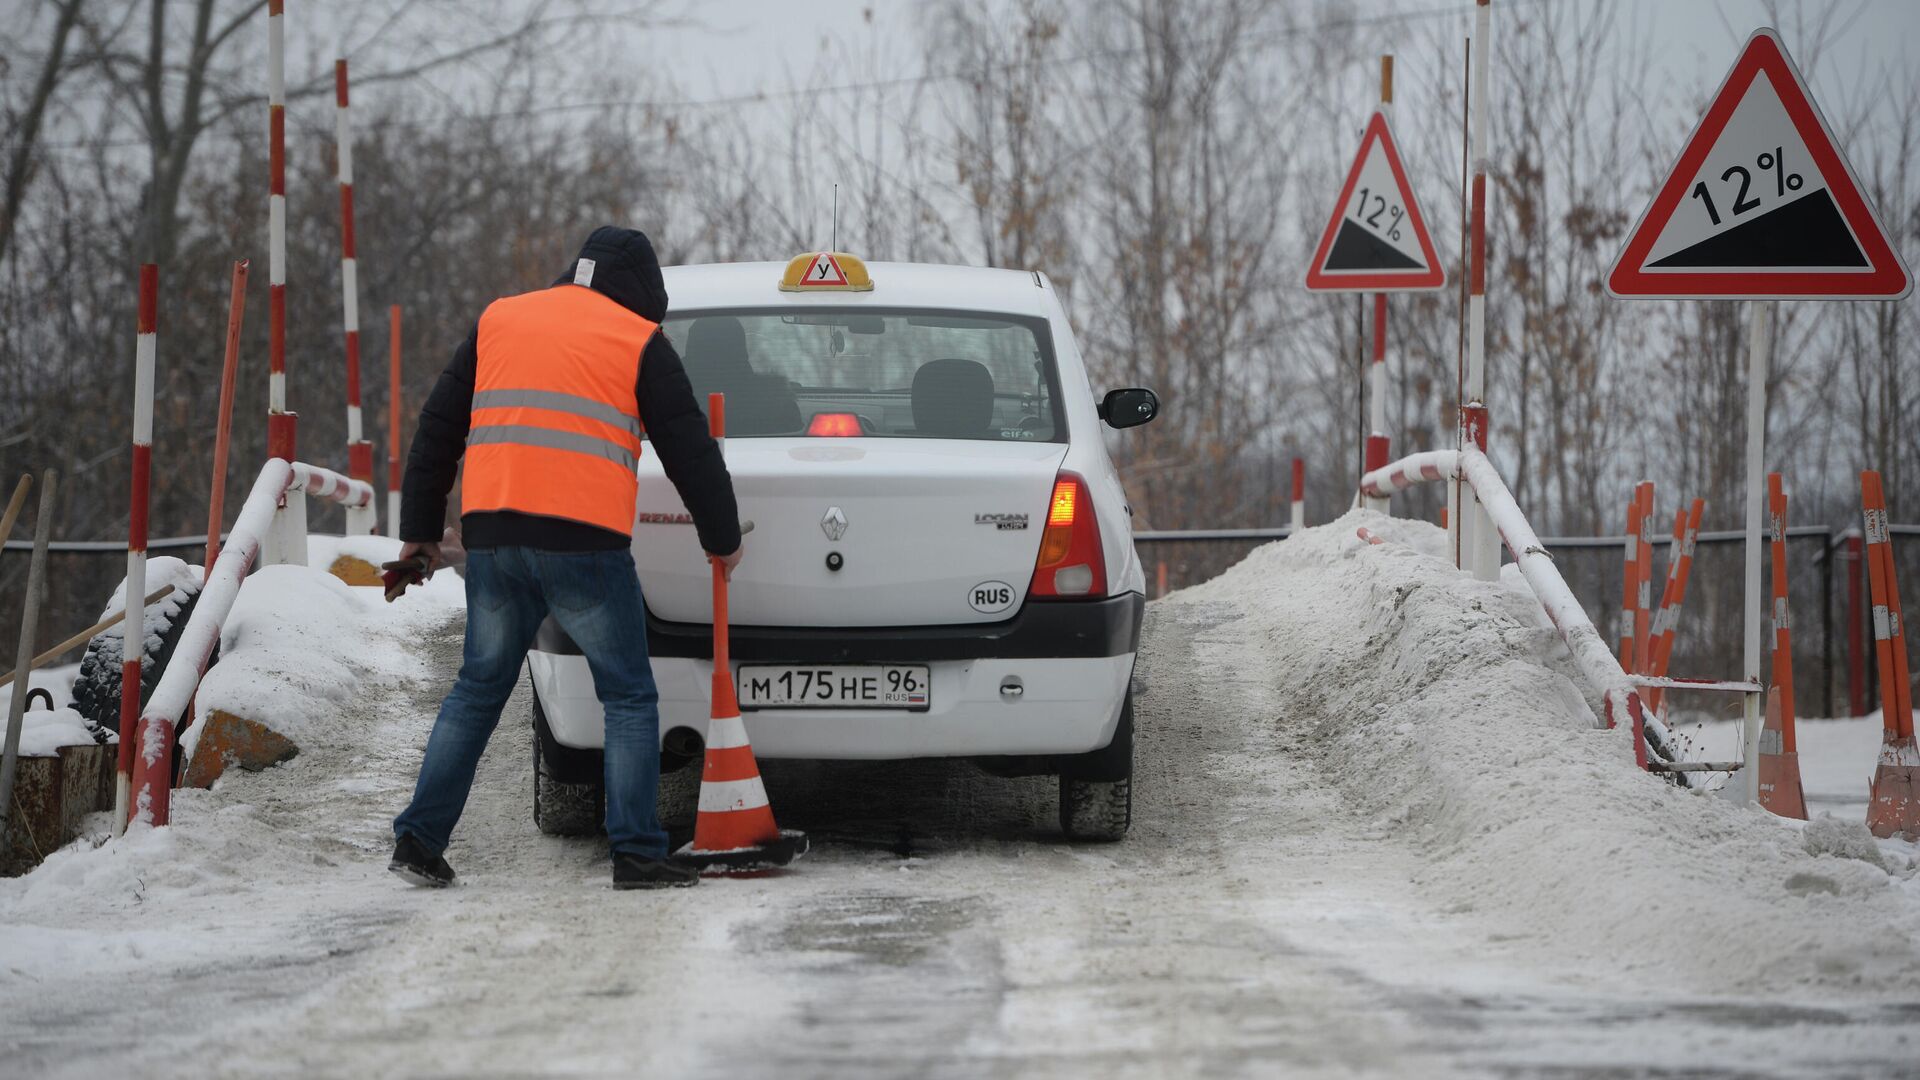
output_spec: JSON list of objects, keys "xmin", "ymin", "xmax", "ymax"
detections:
[{"xmin": 674, "ymin": 394, "xmax": 806, "ymax": 874}]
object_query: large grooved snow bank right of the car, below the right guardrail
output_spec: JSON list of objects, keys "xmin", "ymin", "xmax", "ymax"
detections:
[{"xmin": 1162, "ymin": 511, "xmax": 1920, "ymax": 995}]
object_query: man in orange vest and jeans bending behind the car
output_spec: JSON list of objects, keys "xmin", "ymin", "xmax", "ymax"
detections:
[{"xmin": 390, "ymin": 227, "xmax": 741, "ymax": 888}]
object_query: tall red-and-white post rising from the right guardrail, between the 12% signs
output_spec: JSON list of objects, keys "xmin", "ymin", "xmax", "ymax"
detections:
[{"xmin": 1455, "ymin": 0, "xmax": 1500, "ymax": 580}]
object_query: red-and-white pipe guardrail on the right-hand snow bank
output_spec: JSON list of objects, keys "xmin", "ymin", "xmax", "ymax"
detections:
[{"xmin": 1359, "ymin": 446, "xmax": 1693, "ymax": 786}]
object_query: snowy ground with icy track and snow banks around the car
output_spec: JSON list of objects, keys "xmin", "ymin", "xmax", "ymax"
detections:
[{"xmin": 0, "ymin": 515, "xmax": 1920, "ymax": 1078}]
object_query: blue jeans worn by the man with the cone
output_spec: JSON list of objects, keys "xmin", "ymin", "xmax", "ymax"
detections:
[{"xmin": 394, "ymin": 548, "xmax": 666, "ymax": 859}]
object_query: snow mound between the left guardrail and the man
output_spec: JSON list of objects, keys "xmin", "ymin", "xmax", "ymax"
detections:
[{"xmin": 182, "ymin": 536, "xmax": 465, "ymax": 753}]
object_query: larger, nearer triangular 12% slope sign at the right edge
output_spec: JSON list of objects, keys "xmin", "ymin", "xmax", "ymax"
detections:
[{"xmin": 1607, "ymin": 27, "xmax": 1912, "ymax": 300}]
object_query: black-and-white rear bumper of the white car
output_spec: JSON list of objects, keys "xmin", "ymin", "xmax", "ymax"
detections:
[{"xmin": 528, "ymin": 594, "xmax": 1144, "ymax": 759}]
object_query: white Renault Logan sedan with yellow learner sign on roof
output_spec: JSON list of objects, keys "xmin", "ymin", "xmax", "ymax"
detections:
[{"xmin": 530, "ymin": 252, "xmax": 1158, "ymax": 840}]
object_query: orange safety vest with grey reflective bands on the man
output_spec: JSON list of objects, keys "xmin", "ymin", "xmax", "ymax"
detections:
[{"xmin": 461, "ymin": 284, "xmax": 659, "ymax": 536}]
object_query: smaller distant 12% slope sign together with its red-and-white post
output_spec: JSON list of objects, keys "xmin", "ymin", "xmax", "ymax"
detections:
[{"xmin": 1306, "ymin": 56, "xmax": 1446, "ymax": 511}]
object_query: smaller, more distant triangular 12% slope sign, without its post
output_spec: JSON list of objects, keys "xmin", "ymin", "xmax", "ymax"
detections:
[{"xmin": 1308, "ymin": 111, "xmax": 1446, "ymax": 292}]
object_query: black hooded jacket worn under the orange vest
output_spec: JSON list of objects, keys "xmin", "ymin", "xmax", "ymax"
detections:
[{"xmin": 399, "ymin": 227, "xmax": 739, "ymax": 555}]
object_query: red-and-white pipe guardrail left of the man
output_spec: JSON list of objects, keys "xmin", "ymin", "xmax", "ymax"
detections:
[{"xmin": 115, "ymin": 457, "xmax": 374, "ymax": 826}]
